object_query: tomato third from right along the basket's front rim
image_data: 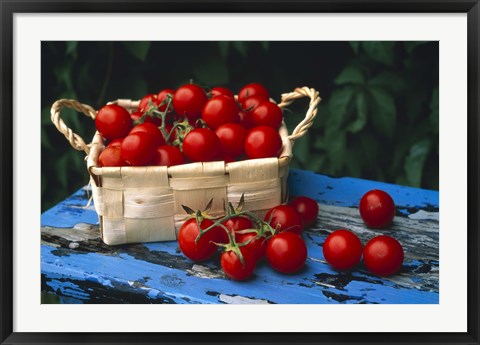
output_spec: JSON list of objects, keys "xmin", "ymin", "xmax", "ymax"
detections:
[{"xmin": 183, "ymin": 128, "xmax": 221, "ymax": 162}]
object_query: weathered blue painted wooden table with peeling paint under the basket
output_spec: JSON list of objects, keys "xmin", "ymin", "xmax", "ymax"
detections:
[{"xmin": 41, "ymin": 169, "xmax": 439, "ymax": 304}]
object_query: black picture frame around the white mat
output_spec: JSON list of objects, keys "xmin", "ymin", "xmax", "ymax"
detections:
[{"xmin": 0, "ymin": 0, "xmax": 480, "ymax": 344}]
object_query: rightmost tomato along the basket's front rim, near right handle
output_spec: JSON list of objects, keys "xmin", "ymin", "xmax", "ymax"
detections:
[{"xmin": 245, "ymin": 126, "xmax": 282, "ymax": 159}]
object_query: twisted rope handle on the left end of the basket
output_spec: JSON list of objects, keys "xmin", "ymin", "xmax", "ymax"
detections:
[{"xmin": 50, "ymin": 99, "xmax": 96, "ymax": 155}]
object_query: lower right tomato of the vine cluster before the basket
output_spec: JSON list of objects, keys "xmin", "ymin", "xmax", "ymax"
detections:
[{"xmin": 265, "ymin": 231, "xmax": 307, "ymax": 273}]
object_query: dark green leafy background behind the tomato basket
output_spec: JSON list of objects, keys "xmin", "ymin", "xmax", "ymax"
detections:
[{"xmin": 41, "ymin": 41, "xmax": 439, "ymax": 211}]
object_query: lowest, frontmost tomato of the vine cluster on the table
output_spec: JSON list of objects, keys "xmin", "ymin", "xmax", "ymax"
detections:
[{"xmin": 220, "ymin": 247, "xmax": 257, "ymax": 281}]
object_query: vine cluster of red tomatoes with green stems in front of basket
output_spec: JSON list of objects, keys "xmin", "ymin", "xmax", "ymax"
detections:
[{"xmin": 178, "ymin": 196, "xmax": 318, "ymax": 280}]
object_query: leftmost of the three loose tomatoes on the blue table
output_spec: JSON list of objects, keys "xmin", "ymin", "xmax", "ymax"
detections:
[{"xmin": 323, "ymin": 229, "xmax": 362, "ymax": 270}]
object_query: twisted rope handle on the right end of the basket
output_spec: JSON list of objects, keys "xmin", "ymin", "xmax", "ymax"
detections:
[{"xmin": 278, "ymin": 86, "xmax": 322, "ymax": 144}]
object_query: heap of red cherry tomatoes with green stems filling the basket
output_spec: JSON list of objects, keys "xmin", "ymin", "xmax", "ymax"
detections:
[{"xmin": 95, "ymin": 83, "xmax": 283, "ymax": 167}]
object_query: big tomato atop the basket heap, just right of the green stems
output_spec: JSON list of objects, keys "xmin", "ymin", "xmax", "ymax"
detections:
[{"xmin": 173, "ymin": 84, "xmax": 208, "ymax": 122}]
